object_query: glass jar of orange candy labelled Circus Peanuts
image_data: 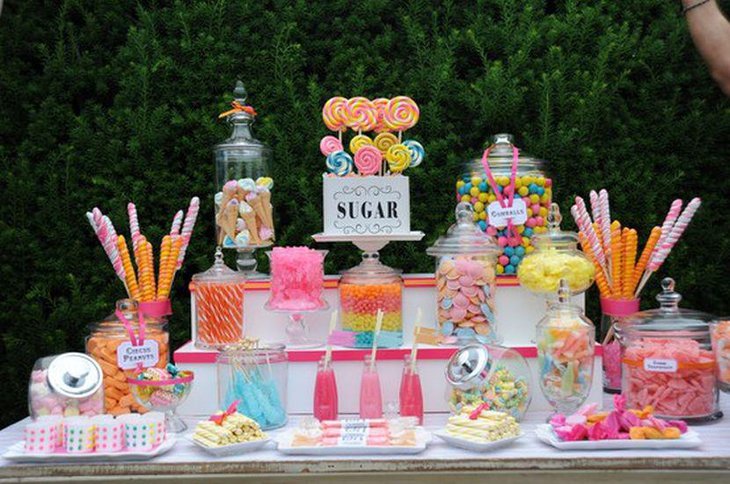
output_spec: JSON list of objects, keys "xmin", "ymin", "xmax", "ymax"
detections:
[{"xmin": 86, "ymin": 299, "xmax": 170, "ymax": 415}]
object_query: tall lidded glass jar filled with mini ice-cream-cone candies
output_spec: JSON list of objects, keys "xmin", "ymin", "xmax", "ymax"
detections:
[{"xmin": 213, "ymin": 81, "xmax": 274, "ymax": 278}]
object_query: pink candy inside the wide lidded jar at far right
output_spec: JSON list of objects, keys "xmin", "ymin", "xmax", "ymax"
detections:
[{"xmin": 622, "ymin": 338, "xmax": 718, "ymax": 418}]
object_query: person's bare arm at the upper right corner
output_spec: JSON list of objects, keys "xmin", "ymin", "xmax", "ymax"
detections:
[{"xmin": 682, "ymin": 0, "xmax": 730, "ymax": 96}]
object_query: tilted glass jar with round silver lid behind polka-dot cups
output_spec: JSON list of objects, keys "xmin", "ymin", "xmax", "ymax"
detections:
[{"xmin": 28, "ymin": 353, "xmax": 104, "ymax": 419}]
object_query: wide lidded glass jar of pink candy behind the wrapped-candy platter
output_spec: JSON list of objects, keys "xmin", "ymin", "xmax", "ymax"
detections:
[{"xmin": 615, "ymin": 278, "xmax": 722, "ymax": 422}]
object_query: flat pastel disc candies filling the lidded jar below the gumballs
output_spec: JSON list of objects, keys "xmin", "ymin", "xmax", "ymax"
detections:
[{"xmin": 436, "ymin": 257, "xmax": 498, "ymax": 342}]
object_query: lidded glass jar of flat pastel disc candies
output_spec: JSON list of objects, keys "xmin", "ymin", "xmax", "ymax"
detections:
[{"xmin": 426, "ymin": 202, "xmax": 501, "ymax": 344}]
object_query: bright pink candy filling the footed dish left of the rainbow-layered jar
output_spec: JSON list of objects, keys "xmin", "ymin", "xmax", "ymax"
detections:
[{"xmin": 269, "ymin": 247, "xmax": 324, "ymax": 311}]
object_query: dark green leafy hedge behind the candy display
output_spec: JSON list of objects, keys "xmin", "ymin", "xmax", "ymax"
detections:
[{"xmin": 0, "ymin": 0, "xmax": 730, "ymax": 424}]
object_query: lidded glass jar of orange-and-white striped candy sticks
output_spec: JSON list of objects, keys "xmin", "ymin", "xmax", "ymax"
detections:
[{"xmin": 191, "ymin": 247, "xmax": 246, "ymax": 349}]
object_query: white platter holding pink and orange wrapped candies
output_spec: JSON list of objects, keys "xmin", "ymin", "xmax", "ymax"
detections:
[{"xmin": 535, "ymin": 424, "xmax": 702, "ymax": 450}]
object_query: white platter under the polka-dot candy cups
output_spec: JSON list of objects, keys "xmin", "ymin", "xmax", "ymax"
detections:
[{"xmin": 3, "ymin": 434, "xmax": 175, "ymax": 463}]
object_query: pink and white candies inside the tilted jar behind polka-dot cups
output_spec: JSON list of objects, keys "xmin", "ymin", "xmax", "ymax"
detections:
[{"xmin": 28, "ymin": 370, "xmax": 104, "ymax": 418}]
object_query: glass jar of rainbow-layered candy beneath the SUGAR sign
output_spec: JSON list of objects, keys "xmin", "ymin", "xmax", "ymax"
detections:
[{"xmin": 339, "ymin": 252, "xmax": 403, "ymax": 348}]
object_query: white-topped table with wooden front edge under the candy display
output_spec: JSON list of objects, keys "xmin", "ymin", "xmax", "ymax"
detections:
[{"xmin": 0, "ymin": 395, "xmax": 730, "ymax": 484}]
